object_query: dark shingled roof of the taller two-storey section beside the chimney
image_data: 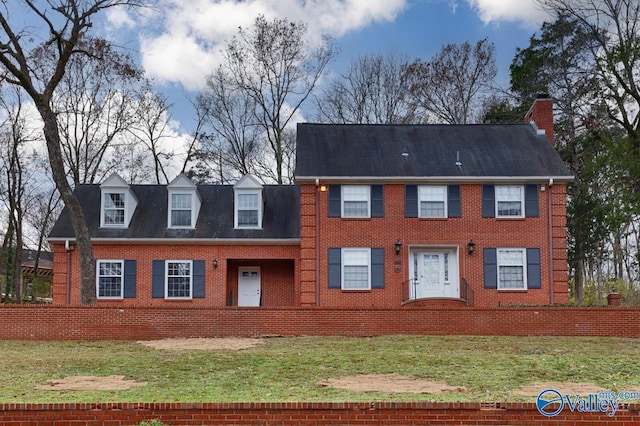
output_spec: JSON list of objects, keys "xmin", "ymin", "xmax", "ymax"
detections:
[{"xmin": 296, "ymin": 123, "xmax": 571, "ymax": 180}]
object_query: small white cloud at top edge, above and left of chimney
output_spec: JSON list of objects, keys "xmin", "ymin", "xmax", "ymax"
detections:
[{"xmin": 467, "ymin": 0, "xmax": 549, "ymax": 29}]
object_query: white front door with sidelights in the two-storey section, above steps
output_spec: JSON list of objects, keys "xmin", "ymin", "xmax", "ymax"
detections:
[{"xmin": 410, "ymin": 250, "xmax": 460, "ymax": 299}]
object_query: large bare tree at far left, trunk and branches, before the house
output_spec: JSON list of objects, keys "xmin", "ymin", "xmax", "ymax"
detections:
[{"xmin": 0, "ymin": 0, "xmax": 139, "ymax": 304}]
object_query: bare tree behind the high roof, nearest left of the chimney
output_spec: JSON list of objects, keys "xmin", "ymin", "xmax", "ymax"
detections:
[{"xmin": 406, "ymin": 39, "xmax": 497, "ymax": 124}]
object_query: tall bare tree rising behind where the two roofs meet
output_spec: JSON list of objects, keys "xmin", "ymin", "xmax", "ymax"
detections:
[{"xmin": 223, "ymin": 16, "xmax": 336, "ymax": 183}]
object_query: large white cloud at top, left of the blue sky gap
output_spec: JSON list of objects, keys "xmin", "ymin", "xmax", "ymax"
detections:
[{"xmin": 133, "ymin": 0, "xmax": 407, "ymax": 90}]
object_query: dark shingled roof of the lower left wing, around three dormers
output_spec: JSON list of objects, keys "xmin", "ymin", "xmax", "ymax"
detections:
[{"xmin": 49, "ymin": 185, "xmax": 300, "ymax": 240}]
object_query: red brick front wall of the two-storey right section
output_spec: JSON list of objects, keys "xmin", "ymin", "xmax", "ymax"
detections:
[{"xmin": 300, "ymin": 182, "xmax": 568, "ymax": 308}]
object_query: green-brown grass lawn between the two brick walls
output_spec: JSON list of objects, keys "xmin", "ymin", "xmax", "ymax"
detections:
[{"xmin": 0, "ymin": 336, "xmax": 640, "ymax": 403}]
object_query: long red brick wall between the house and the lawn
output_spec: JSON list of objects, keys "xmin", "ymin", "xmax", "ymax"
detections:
[{"xmin": 0, "ymin": 305, "xmax": 640, "ymax": 340}]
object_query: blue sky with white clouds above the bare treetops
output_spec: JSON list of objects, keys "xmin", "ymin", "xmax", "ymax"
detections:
[{"xmin": 4, "ymin": 0, "xmax": 545, "ymax": 133}]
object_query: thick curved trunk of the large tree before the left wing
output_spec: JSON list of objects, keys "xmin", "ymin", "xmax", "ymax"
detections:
[{"xmin": 36, "ymin": 101, "xmax": 97, "ymax": 305}]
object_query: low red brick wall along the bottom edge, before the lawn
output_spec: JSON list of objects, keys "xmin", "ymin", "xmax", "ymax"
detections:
[{"xmin": 0, "ymin": 402, "xmax": 640, "ymax": 426}]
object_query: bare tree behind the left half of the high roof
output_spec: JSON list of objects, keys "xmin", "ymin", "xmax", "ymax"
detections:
[{"xmin": 316, "ymin": 54, "xmax": 416, "ymax": 124}]
